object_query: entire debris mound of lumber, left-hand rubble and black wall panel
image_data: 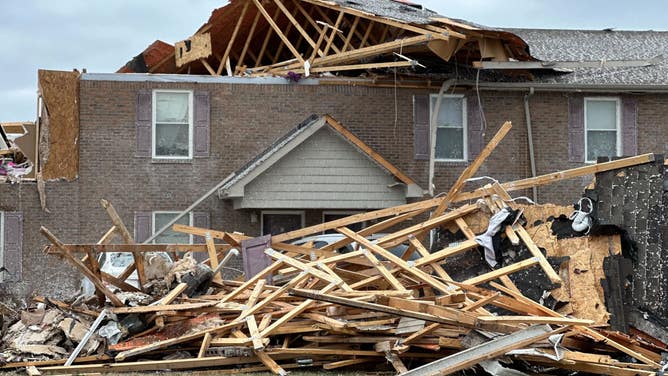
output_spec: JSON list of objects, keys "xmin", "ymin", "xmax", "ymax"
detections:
[{"xmin": 0, "ymin": 122, "xmax": 668, "ymax": 375}]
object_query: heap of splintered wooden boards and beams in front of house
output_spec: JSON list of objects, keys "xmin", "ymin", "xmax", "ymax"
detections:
[{"xmin": 6, "ymin": 125, "xmax": 666, "ymax": 375}]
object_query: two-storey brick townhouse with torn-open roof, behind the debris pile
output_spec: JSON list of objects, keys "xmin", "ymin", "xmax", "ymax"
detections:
[{"xmin": 0, "ymin": 0, "xmax": 668, "ymax": 298}]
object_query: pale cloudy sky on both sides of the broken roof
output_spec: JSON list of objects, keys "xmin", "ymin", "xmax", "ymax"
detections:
[{"xmin": 0, "ymin": 0, "xmax": 668, "ymax": 122}]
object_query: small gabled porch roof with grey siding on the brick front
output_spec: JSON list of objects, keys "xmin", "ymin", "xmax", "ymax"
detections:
[{"xmin": 218, "ymin": 115, "xmax": 422, "ymax": 209}]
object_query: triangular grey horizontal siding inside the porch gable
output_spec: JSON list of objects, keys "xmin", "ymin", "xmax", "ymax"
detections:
[{"xmin": 235, "ymin": 128, "xmax": 406, "ymax": 209}]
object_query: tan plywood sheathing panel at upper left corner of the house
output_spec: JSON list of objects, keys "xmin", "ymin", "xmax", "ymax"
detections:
[{"xmin": 37, "ymin": 70, "xmax": 79, "ymax": 180}]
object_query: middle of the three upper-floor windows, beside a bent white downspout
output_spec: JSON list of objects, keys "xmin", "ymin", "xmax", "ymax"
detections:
[{"xmin": 429, "ymin": 94, "xmax": 468, "ymax": 161}]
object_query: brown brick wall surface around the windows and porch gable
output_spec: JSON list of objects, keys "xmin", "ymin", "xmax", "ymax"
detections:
[{"xmin": 0, "ymin": 80, "xmax": 668, "ymax": 302}]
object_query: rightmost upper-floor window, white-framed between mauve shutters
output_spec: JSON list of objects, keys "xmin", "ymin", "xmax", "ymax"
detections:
[{"xmin": 584, "ymin": 98, "xmax": 622, "ymax": 162}]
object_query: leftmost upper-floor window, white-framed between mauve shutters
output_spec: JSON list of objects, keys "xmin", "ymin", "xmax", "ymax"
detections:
[{"xmin": 151, "ymin": 90, "xmax": 193, "ymax": 159}]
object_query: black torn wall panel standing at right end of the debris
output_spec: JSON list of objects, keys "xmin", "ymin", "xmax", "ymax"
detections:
[{"xmin": 588, "ymin": 155, "xmax": 668, "ymax": 320}]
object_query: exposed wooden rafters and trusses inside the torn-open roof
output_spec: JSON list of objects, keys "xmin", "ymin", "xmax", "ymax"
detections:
[{"xmin": 142, "ymin": 0, "xmax": 512, "ymax": 76}]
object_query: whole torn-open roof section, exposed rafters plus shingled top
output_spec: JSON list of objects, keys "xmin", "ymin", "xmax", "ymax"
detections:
[{"xmin": 119, "ymin": 0, "xmax": 533, "ymax": 78}]
